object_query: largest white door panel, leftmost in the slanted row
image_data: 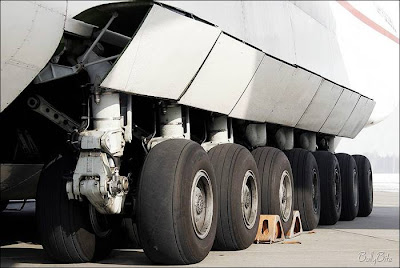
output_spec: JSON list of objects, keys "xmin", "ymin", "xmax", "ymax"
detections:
[{"xmin": 101, "ymin": 5, "xmax": 220, "ymax": 99}]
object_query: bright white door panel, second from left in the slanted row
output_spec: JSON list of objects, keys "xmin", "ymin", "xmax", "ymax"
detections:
[{"xmin": 179, "ymin": 34, "xmax": 264, "ymax": 114}]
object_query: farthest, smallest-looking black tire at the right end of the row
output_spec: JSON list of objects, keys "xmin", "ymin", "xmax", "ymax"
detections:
[{"xmin": 353, "ymin": 155, "xmax": 374, "ymax": 217}]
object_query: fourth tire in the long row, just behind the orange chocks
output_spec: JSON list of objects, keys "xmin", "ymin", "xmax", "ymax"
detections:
[{"xmin": 285, "ymin": 148, "xmax": 321, "ymax": 231}]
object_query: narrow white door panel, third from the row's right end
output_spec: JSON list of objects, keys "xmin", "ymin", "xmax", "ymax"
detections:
[{"xmin": 296, "ymin": 80, "xmax": 343, "ymax": 132}]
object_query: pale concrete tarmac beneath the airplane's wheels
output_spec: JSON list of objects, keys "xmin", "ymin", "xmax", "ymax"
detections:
[{"xmin": 0, "ymin": 189, "xmax": 399, "ymax": 267}]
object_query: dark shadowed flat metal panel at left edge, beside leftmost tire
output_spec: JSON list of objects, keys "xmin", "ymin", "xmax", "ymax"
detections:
[{"xmin": 0, "ymin": 164, "xmax": 43, "ymax": 200}]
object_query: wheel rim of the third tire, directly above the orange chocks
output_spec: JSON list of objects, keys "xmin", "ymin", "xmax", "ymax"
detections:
[{"xmin": 279, "ymin": 170, "xmax": 292, "ymax": 222}]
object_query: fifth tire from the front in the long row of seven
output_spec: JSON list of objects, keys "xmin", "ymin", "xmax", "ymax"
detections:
[{"xmin": 313, "ymin": 151, "xmax": 342, "ymax": 225}]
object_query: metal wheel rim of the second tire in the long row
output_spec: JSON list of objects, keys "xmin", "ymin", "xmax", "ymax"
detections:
[{"xmin": 241, "ymin": 170, "xmax": 258, "ymax": 229}]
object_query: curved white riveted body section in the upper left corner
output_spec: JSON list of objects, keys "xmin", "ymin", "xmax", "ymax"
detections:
[{"xmin": 1, "ymin": 1, "xmax": 66, "ymax": 111}]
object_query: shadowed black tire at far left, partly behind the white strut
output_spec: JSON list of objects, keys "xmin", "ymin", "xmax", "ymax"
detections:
[{"xmin": 36, "ymin": 157, "xmax": 112, "ymax": 263}]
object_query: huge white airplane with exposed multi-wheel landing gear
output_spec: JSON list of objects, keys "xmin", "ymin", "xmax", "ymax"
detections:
[{"xmin": 0, "ymin": 0, "xmax": 399, "ymax": 264}]
